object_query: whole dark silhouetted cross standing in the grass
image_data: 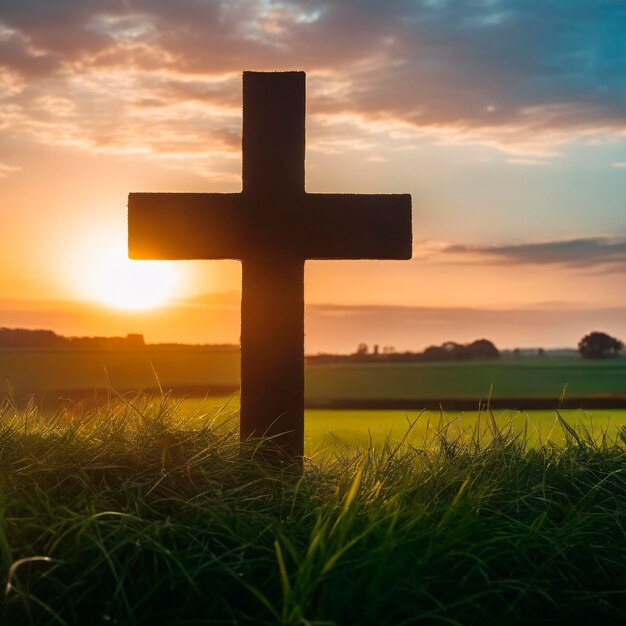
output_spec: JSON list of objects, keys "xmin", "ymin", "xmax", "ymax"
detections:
[{"xmin": 128, "ymin": 72, "xmax": 412, "ymax": 462}]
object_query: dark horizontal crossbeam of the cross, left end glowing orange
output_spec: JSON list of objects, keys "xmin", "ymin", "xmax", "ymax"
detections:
[{"xmin": 128, "ymin": 193, "xmax": 411, "ymax": 260}]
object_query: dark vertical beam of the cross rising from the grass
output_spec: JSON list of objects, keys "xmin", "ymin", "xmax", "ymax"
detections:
[{"xmin": 240, "ymin": 72, "xmax": 305, "ymax": 459}]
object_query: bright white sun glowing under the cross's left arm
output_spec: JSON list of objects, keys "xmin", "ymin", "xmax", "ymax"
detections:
[{"xmin": 89, "ymin": 245, "xmax": 177, "ymax": 310}]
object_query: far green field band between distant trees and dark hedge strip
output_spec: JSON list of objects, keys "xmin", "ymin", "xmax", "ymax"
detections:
[{"xmin": 0, "ymin": 346, "xmax": 626, "ymax": 408}]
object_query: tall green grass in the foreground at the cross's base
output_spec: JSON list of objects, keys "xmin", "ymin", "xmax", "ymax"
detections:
[{"xmin": 0, "ymin": 399, "xmax": 626, "ymax": 625}]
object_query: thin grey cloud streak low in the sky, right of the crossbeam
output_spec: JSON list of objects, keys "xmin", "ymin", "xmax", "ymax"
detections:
[{"xmin": 442, "ymin": 237, "xmax": 626, "ymax": 271}]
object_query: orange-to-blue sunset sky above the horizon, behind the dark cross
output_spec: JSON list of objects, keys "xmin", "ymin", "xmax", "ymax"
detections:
[{"xmin": 0, "ymin": 0, "xmax": 626, "ymax": 353}]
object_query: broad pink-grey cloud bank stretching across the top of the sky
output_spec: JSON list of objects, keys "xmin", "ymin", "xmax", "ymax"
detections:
[{"xmin": 0, "ymin": 0, "xmax": 626, "ymax": 161}]
